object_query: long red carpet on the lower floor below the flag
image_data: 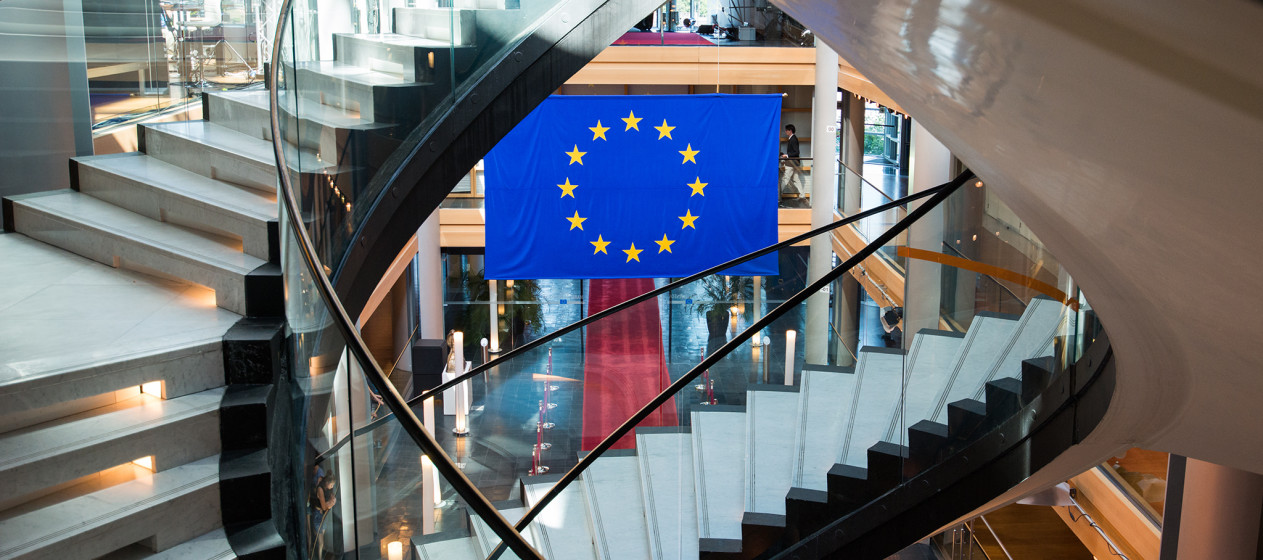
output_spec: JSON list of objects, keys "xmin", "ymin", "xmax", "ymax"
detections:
[{"xmin": 580, "ymin": 278, "xmax": 678, "ymax": 450}]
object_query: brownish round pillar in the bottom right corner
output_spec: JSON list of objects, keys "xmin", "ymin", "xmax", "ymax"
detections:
[{"xmin": 1162, "ymin": 459, "xmax": 1263, "ymax": 560}]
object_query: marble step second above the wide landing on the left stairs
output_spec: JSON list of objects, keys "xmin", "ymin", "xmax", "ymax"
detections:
[{"xmin": 72, "ymin": 154, "xmax": 279, "ymax": 260}]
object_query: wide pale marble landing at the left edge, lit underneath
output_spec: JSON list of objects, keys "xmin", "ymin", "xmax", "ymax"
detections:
[{"xmin": 0, "ymin": 235, "xmax": 240, "ymax": 432}]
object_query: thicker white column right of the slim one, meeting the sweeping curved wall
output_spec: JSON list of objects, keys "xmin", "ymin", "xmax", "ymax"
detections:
[{"xmin": 903, "ymin": 123, "xmax": 951, "ymax": 348}]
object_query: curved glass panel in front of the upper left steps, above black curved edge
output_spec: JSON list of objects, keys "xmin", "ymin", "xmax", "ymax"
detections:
[{"xmin": 276, "ymin": 0, "xmax": 573, "ymax": 273}]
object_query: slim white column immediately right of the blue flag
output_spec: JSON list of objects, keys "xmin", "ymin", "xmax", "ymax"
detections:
[{"xmin": 803, "ymin": 42, "xmax": 837, "ymax": 364}]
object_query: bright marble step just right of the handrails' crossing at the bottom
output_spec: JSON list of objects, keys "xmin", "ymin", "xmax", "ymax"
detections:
[{"xmin": 522, "ymin": 473, "xmax": 596, "ymax": 560}]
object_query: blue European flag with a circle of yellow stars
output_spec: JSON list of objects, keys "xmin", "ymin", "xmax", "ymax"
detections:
[{"xmin": 485, "ymin": 94, "xmax": 781, "ymax": 279}]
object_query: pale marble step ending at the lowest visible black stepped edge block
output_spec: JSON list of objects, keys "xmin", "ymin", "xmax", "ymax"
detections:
[{"xmin": 691, "ymin": 406, "xmax": 746, "ymax": 552}]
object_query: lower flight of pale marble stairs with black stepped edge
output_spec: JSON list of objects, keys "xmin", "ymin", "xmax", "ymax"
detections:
[{"xmin": 414, "ymin": 298, "xmax": 1062, "ymax": 560}]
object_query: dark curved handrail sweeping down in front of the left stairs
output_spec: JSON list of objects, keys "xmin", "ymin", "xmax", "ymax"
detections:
[{"xmin": 268, "ymin": 0, "xmax": 543, "ymax": 560}]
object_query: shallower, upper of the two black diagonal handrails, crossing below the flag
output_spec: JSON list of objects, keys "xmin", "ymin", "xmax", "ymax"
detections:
[{"xmin": 408, "ymin": 186, "xmax": 942, "ymax": 406}]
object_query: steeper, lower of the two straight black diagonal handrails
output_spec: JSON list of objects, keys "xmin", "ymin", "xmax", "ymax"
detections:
[{"xmin": 488, "ymin": 169, "xmax": 974, "ymax": 560}]
